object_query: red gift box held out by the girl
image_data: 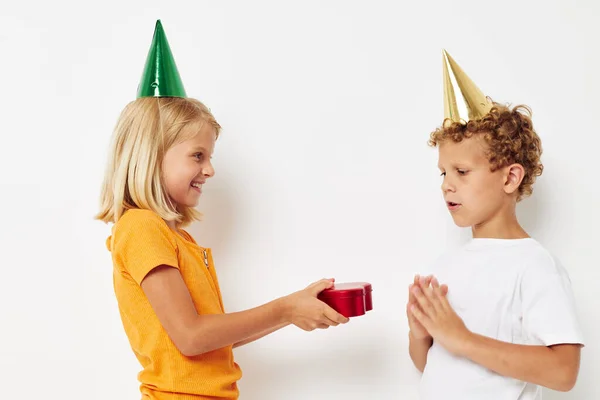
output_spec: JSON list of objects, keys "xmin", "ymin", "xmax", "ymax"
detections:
[{"xmin": 317, "ymin": 282, "xmax": 373, "ymax": 318}]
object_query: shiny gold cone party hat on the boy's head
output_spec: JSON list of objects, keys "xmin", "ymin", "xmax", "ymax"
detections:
[{"xmin": 442, "ymin": 50, "xmax": 492, "ymax": 122}]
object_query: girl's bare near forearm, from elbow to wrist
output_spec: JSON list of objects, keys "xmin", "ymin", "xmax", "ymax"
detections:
[{"xmin": 184, "ymin": 299, "xmax": 287, "ymax": 356}]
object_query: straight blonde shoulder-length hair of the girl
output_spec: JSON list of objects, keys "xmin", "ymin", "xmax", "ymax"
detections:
[{"xmin": 95, "ymin": 97, "xmax": 221, "ymax": 226}]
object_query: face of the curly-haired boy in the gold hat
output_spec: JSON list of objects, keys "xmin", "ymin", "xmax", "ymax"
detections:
[{"xmin": 438, "ymin": 136, "xmax": 512, "ymax": 227}]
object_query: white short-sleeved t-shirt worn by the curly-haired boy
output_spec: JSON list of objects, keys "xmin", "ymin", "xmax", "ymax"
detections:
[{"xmin": 420, "ymin": 238, "xmax": 583, "ymax": 400}]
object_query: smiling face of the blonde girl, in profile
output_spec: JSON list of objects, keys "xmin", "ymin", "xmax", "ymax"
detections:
[{"xmin": 162, "ymin": 124, "xmax": 216, "ymax": 208}]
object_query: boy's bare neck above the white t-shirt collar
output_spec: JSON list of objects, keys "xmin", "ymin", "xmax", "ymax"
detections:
[{"xmin": 471, "ymin": 204, "xmax": 529, "ymax": 239}]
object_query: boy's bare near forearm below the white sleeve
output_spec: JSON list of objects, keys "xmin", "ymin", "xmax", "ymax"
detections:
[{"xmin": 461, "ymin": 333, "xmax": 579, "ymax": 391}]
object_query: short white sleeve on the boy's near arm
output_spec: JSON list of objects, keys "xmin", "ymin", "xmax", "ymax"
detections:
[{"xmin": 521, "ymin": 255, "xmax": 584, "ymax": 346}]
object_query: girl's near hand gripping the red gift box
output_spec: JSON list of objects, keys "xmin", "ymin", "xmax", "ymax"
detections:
[{"xmin": 282, "ymin": 279, "xmax": 349, "ymax": 331}]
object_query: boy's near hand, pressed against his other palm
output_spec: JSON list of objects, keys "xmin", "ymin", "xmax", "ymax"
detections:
[{"xmin": 411, "ymin": 278, "xmax": 471, "ymax": 356}]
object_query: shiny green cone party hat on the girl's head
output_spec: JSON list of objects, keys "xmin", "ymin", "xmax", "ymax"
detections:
[{"xmin": 137, "ymin": 20, "xmax": 187, "ymax": 98}]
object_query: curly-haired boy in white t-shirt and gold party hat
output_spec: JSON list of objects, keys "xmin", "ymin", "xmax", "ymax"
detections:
[{"xmin": 407, "ymin": 51, "xmax": 583, "ymax": 400}]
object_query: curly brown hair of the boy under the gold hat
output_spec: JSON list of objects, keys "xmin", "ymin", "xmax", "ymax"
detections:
[{"xmin": 428, "ymin": 103, "xmax": 544, "ymax": 201}]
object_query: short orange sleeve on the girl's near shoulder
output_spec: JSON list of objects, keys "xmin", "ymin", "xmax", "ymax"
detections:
[{"xmin": 112, "ymin": 210, "xmax": 179, "ymax": 285}]
